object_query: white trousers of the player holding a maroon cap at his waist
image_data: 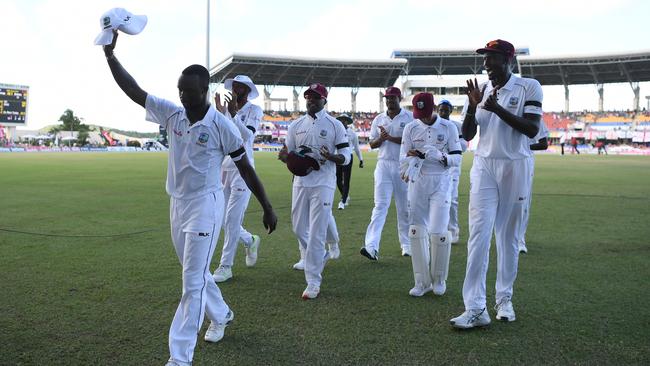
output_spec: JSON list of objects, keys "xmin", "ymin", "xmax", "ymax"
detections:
[{"xmin": 291, "ymin": 186, "xmax": 334, "ymax": 286}]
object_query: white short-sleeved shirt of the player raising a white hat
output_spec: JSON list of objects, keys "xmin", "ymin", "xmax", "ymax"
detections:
[{"xmin": 145, "ymin": 94, "xmax": 245, "ymax": 199}]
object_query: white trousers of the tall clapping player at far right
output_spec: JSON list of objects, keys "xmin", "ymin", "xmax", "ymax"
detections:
[{"xmin": 463, "ymin": 156, "xmax": 530, "ymax": 310}]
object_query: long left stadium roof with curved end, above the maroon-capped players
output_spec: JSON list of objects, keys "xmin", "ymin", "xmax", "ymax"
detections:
[{"xmin": 210, "ymin": 53, "xmax": 407, "ymax": 88}]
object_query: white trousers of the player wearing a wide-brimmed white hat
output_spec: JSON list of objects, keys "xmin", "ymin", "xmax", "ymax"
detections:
[{"xmin": 215, "ymin": 170, "xmax": 253, "ymax": 266}]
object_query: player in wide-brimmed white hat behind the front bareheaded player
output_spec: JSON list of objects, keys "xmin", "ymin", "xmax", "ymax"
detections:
[{"xmin": 213, "ymin": 75, "xmax": 263, "ymax": 282}]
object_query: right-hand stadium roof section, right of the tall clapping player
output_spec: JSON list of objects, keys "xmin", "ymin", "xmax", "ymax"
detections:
[{"xmin": 519, "ymin": 51, "xmax": 650, "ymax": 85}]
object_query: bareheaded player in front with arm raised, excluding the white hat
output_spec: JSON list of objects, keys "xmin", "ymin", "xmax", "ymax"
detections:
[{"xmin": 104, "ymin": 31, "xmax": 277, "ymax": 366}]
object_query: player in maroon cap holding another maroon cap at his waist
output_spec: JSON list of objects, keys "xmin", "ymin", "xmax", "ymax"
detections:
[{"xmin": 287, "ymin": 83, "xmax": 350, "ymax": 300}]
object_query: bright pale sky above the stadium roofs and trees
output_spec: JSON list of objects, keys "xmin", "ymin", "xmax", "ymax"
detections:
[{"xmin": 0, "ymin": 0, "xmax": 650, "ymax": 131}]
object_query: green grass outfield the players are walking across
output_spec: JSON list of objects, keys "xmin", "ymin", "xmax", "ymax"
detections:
[{"xmin": 0, "ymin": 153, "xmax": 650, "ymax": 365}]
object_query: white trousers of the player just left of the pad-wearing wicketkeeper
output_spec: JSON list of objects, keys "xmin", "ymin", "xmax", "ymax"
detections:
[{"xmin": 365, "ymin": 159, "xmax": 410, "ymax": 253}]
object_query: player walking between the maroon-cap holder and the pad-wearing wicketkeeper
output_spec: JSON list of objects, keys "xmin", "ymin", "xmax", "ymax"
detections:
[{"xmin": 360, "ymin": 86, "xmax": 413, "ymax": 261}]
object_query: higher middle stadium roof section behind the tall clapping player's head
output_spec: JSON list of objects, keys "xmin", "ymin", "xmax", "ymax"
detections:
[{"xmin": 392, "ymin": 48, "xmax": 529, "ymax": 75}]
